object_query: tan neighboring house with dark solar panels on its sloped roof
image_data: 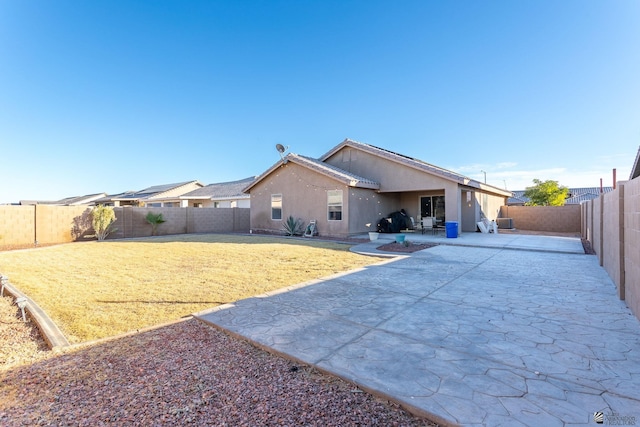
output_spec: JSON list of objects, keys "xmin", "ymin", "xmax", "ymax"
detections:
[{"xmin": 96, "ymin": 180, "xmax": 203, "ymax": 207}]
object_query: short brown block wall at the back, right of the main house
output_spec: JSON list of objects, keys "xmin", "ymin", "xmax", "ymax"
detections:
[{"xmin": 500, "ymin": 205, "xmax": 581, "ymax": 233}]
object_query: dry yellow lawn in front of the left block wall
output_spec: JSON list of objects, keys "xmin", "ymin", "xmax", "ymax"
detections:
[{"xmin": 0, "ymin": 235, "xmax": 378, "ymax": 343}]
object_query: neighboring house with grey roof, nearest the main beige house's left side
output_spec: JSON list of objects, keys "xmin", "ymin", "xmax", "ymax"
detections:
[{"xmin": 180, "ymin": 176, "xmax": 256, "ymax": 208}]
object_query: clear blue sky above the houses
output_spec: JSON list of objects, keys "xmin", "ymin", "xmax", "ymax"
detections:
[{"xmin": 0, "ymin": 0, "xmax": 640, "ymax": 202}]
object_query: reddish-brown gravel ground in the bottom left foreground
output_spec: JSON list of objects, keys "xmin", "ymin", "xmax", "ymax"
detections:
[{"xmin": 0, "ymin": 298, "xmax": 436, "ymax": 427}]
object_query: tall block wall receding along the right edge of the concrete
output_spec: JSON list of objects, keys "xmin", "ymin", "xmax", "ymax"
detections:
[{"xmin": 580, "ymin": 178, "xmax": 640, "ymax": 319}]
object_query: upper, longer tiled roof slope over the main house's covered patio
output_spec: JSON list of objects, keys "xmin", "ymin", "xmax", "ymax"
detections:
[{"xmin": 320, "ymin": 138, "xmax": 511, "ymax": 196}]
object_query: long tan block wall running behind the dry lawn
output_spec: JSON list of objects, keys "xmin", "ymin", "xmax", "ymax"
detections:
[{"xmin": 0, "ymin": 205, "xmax": 250, "ymax": 247}]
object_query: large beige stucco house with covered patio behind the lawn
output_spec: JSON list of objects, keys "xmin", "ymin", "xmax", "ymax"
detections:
[{"xmin": 245, "ymin": 139, "xmax": 512, "ymax": 237}]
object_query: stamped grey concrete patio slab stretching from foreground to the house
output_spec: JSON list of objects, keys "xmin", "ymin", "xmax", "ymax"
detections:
[{"xmin": 197, "ymin": 233, "xmax": 640, "ymax": 426}]
